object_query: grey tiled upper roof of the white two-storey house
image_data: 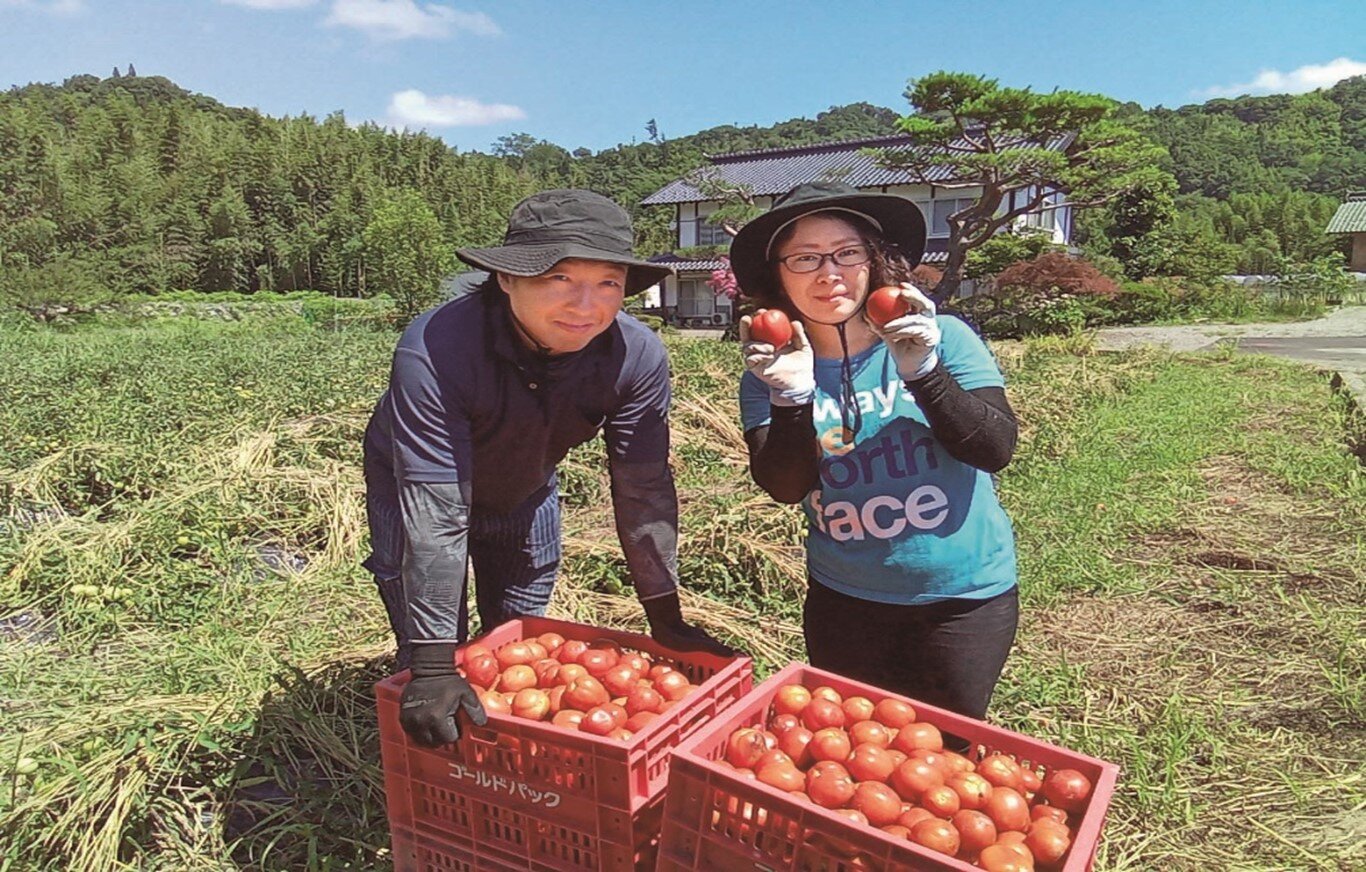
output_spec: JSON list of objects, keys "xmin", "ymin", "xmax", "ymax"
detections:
[{"xmin": 641, "ymin": 135, "xmax": 1072, "ymax": 206}]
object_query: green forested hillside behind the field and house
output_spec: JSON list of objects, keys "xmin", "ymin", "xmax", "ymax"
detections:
[{"xmin": 0, "ymin": 67, "xmax": 1366, "ymax": 303}]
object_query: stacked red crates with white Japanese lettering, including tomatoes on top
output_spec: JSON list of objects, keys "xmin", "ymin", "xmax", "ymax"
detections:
[{"xmin": 376, "ymin": 618, "xmax": 753, "ymax": 872}]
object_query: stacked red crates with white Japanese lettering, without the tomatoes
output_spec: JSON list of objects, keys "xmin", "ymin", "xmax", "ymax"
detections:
[{"xmin": 374, "ymin": 618, "xmax": 753, "ymax": 872}]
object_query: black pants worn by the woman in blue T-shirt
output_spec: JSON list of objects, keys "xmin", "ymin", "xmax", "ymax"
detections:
[{"xmin": 802, "ymin": 581, "xmax": 1019, "ymax": 719}]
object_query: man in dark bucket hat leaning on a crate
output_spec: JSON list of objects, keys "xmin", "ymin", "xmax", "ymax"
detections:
[{"xmin": 365, "ymin": 190, "xmax": 729, "ymax": 745}]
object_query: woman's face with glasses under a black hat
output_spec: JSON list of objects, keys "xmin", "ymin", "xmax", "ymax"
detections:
[{"xmin": 773, "ymin": 215, "xmax": 870, "ymax": 324}]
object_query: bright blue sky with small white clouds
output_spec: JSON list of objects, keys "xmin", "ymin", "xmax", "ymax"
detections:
[{"xmin": 0, "ymin": 0, "xmax": 1366, "ymax": 150}]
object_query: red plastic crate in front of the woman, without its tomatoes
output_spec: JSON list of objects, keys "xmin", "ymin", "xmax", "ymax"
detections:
[{"xmin": 657, "ymin": 663, "xmax": 1119, "ymax": 872}]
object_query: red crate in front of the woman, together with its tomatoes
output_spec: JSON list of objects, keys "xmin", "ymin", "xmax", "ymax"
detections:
[{"xmin": 658, "ymin": 664, "xmax": 1119, "ymax": 872}]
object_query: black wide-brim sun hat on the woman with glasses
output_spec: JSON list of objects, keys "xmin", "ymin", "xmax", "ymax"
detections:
[{"xmin": 731, "ymin": 182, "xmax": 925, "ymax": 297}]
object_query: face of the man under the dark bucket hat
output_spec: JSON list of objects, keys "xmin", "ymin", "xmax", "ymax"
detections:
[{"xmin": 499, "ymin": 258, "xmax": 626, "ymax": 354}]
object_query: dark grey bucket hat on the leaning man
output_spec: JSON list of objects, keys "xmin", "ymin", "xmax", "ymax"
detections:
[{"xmin": 456, "ymin": 189, "xmax": 673, "ymax": 297}]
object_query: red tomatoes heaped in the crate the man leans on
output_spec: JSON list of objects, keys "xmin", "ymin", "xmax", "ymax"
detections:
[{"xmin": 456, "ymin": 633, "xmax": 694, "ymax": 741}]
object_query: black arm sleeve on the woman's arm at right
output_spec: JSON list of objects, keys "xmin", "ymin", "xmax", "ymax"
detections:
[{"xmin": 906, "ymin": 361, "xmax": 1019, "ymax": 473}]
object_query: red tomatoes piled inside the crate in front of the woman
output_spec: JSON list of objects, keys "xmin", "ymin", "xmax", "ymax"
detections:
[{"xmin": 723, "ymin": 685, "xmax": 1091, "ymax": 872}]
